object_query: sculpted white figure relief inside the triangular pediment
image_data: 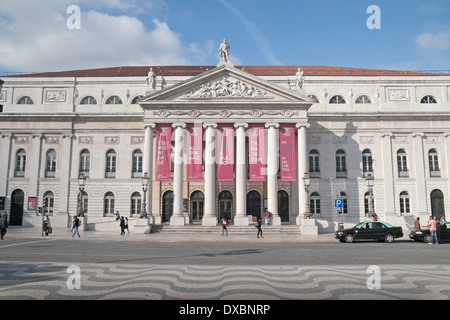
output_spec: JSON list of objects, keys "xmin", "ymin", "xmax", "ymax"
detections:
[{"xmin": 180, "ymin": 77, "xmax": 274, "ymax": 100}]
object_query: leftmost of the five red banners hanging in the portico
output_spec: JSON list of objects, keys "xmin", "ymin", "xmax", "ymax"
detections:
[{"xmin": 155, "ymin": 124, "xmax": 172, "ymax": 181}]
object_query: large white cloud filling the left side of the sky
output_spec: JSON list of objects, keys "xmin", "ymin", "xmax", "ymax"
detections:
[{"xmin": 0, "ymin": 0, "xmax": 204, "ymax": 71}]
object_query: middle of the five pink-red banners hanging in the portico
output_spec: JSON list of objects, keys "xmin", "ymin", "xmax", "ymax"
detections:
[{"xmin": 216, "ymin": 124, "xmax": 234, "ymax": 181}]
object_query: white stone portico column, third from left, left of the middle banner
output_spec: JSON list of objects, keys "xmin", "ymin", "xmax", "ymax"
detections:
[{"xmin": 202, "ymin": 123, "xmax": 217, "ymax": 226}]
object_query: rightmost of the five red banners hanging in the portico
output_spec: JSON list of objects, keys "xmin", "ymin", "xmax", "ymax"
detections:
[{"xmin": 280, "ymin": 124, "xmax": 297, "ymax": 181}]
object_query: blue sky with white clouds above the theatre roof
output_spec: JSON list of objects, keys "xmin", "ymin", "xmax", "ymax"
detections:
[{"xmin": 0, "ymin": 0, "xmax": 450, "ymax": 72}]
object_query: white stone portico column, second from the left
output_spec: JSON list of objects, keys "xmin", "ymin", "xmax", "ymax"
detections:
[{"xmin": 170, "ymin": 122, "xmax": 186, "ymax": 226}]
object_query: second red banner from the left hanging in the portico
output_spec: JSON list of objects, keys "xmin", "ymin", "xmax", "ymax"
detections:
[{"xmin": 186, "ymin": 124, "xmax": 203, "ymax": 181}]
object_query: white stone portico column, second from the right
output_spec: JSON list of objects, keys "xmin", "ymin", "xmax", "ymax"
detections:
[{"xmin": 265, "ymin": 123, "xmax": 281, "ymax": 226}]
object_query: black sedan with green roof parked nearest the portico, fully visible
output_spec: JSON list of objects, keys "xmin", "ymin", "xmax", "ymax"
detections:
[{"xmin": 334, "ymin": 221, "xmax": 403, "ymax": 243}]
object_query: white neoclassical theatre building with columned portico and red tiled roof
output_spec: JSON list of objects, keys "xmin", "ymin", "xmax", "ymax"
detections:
[{"xmin": 0, "ymin": 61, "xmax": 450, "ymax": 232}]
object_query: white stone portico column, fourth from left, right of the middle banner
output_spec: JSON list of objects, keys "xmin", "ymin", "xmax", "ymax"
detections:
[{"xmin": 234, "ymin": 122, "xmax": 248, "ymax": 226}]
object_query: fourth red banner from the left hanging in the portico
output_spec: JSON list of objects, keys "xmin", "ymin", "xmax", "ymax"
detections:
[{"xmin": 248, "ymin": 124, "xmax": 266, "ymax": 181}]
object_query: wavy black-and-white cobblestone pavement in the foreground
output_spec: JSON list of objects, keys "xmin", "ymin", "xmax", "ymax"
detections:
[{"xmin": 0, "ymin": 262, "xmax": 450, "ymax": 300}]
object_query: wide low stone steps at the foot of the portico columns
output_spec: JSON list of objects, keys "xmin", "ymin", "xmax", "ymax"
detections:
[{"xmin": 151, "ymin": 224, "xmax": 301, "ymax": 235}]
